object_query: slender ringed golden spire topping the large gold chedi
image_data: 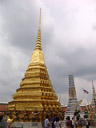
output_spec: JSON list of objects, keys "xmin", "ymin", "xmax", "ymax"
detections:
[{"xmin": 35, "ymin": 9, "xmax": 42, "ymax": 50}]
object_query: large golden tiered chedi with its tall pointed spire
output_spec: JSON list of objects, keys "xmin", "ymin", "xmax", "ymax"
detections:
[{"xmin": 7, "ymin": 10, "xmax": 61, "ymax": 122}]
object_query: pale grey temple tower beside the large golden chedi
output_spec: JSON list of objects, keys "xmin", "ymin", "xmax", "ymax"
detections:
[{"xmin": 65, "ymin": 73, "xmax": 81, "ymax": 119}]
